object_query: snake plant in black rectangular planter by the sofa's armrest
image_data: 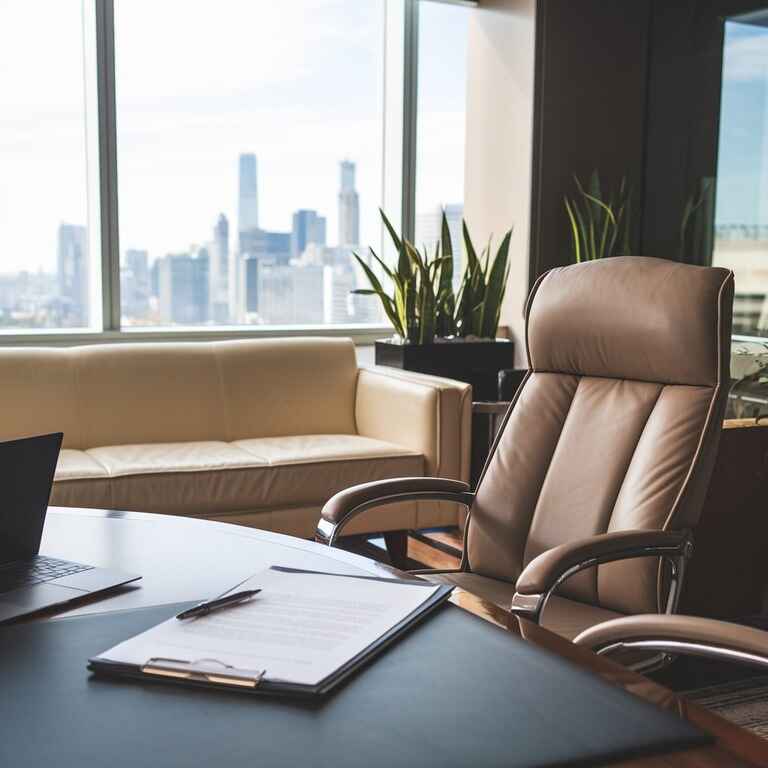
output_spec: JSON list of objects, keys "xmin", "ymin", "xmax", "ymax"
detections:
[{"xmin": 354, "ymin": 211, "xmax": 514, "ymax": 400}]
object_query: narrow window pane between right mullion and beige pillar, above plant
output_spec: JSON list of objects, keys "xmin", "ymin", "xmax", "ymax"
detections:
[{"xmin": 416, "ymin": 2, "xmax": 471, "ymax": 287}]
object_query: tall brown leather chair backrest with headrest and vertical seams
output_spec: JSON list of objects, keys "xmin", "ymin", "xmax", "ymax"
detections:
[{"xmin": 467, "ymin": 256, "xmax": 733, "ymax": 613}]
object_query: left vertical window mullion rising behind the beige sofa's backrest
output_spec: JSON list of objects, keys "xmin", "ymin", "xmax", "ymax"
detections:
[{"xmin": 94, "ymin": 0, "xmax": 120, "ymax": 331}]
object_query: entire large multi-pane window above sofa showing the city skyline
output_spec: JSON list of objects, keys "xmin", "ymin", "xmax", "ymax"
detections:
[{"xmin": 0, "ymin": 0, "xmax": 472, "ymax": 343}]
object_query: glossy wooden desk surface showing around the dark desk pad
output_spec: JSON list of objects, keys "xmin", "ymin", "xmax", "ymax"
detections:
[{"xmin": 22, "ymin": 508, "xmax": 768, "ymax": 768}]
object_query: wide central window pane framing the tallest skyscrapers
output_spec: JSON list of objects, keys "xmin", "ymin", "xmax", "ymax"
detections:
[{"xmin": 115, "ymin": 0, "xmax": 386, "ymax": 326}]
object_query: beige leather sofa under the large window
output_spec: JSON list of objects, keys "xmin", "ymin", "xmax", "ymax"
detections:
[{"xmin": 0, "ymin": 338, "xmax": 471, "ymax": 536}]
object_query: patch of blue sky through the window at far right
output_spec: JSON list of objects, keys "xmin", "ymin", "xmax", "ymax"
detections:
[{"xmin": 715, "ymin": 21, "xmax": 768, "ymax": 226}]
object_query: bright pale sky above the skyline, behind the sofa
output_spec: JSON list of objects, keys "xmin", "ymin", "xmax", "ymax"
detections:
[{"xmin": 0, "ymin": 0, "xmax": 469, "ymax": 272}]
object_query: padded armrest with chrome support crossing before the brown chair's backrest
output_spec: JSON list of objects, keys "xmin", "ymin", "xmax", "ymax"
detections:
[{"xmin": 509, "ymin": 531, "xmax": 693, "ymax": 623}]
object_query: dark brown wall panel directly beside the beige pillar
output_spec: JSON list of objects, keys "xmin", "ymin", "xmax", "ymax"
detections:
[{"xmin": 531, "ymin": 0, "xmax": 651, "ymax": 282}]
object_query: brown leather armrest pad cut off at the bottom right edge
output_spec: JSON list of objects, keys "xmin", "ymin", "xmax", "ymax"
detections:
[{"xmin": 576, "ymin": 615, "xmax": 768, "ymax": 659}]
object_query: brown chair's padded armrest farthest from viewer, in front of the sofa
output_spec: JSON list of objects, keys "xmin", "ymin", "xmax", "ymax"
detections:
[{"xmin": 315, "ymin": 477, "xmax": 474, "ymax": 546}]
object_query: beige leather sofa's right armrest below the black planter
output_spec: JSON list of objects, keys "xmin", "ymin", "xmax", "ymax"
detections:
[{"xmin": 355, "ymin": 367, "xmax": 472, "ymax": 482}]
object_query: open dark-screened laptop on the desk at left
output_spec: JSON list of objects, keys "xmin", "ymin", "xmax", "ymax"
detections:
[{"xmin": 0, "ymin": 432, "xmax": 141, "ymax": 623}]
